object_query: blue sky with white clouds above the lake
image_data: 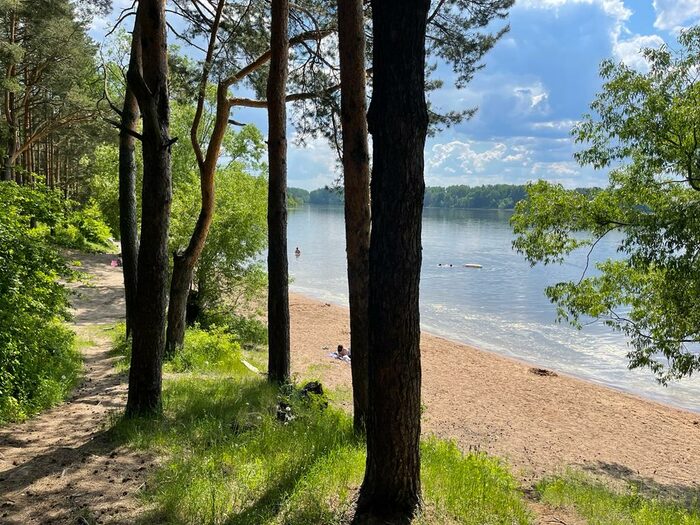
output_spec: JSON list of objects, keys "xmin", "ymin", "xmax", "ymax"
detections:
[{"xmin": 95, "ymin": 0, "xmax": 700, "ymax": 190}]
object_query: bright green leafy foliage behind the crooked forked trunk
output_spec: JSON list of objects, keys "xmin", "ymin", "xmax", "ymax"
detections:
[{"xmin": 170, "ymin": 113, "xmax": 267, "ymax": 320}]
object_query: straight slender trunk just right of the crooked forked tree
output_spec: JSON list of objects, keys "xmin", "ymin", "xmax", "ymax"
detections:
[{"xmin": 267, "ymin": 0, "xmax": 290, "ymax": 383}]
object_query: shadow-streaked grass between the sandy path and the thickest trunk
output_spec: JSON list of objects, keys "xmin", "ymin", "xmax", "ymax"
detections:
[{"xmin": 115, "ymin": 372, "xmax": 364, "ymax": 524}]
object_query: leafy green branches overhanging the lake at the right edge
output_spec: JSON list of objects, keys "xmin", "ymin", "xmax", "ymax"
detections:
[{"xmin": 512, "ymin": 28, "xmax": 700, "ymax": 383}]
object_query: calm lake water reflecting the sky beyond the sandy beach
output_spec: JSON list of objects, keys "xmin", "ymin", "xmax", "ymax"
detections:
[{"xmin": 288, "ymin": 206, "xmax": 700, "ymax": 411}]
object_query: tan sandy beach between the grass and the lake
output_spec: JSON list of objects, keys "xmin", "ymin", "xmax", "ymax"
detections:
[{"xmin": 290, "ymin": 294, "xmax": 700, "ymax": 496}]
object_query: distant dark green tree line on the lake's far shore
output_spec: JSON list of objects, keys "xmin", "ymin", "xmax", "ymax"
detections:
[{"xmin": 287, "ymin": 184, "xmax": 598, "ymax": 210}]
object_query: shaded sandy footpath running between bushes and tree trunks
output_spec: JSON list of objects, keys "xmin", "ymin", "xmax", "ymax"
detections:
[{"xmin": 0, "ymin": 254, "xmax": 151, "ymax": 525}]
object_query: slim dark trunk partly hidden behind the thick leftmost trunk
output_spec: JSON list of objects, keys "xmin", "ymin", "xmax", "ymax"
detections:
[{"xmin": 119, "ymin": 17, "xmax": 141, "ymax": 337}]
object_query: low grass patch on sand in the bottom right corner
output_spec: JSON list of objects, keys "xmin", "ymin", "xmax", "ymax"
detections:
[{"xmin": 537, "ymin": 471, "xmax": 700, "ymax": 525}]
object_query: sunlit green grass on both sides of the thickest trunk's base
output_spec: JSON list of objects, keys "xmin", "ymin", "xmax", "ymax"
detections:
[{"xmin": 113, "ymin": 326, "xmax": 531, "ymax": 525}]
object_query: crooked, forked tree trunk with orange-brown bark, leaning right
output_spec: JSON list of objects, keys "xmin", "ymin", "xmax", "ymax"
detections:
[{"xmin": 165, "ymin": 0, "xmax": 226, "ymax": 355}]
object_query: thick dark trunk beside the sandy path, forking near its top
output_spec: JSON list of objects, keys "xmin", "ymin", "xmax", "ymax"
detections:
[{"xmin": 126, "ymin": 0, "xmax": 172, "ymax": 416}]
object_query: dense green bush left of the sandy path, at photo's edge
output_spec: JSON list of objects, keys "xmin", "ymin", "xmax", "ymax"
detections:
[{"xmin": 0, "ymin": 182, "xmax": 81, "ymax": 423}]
